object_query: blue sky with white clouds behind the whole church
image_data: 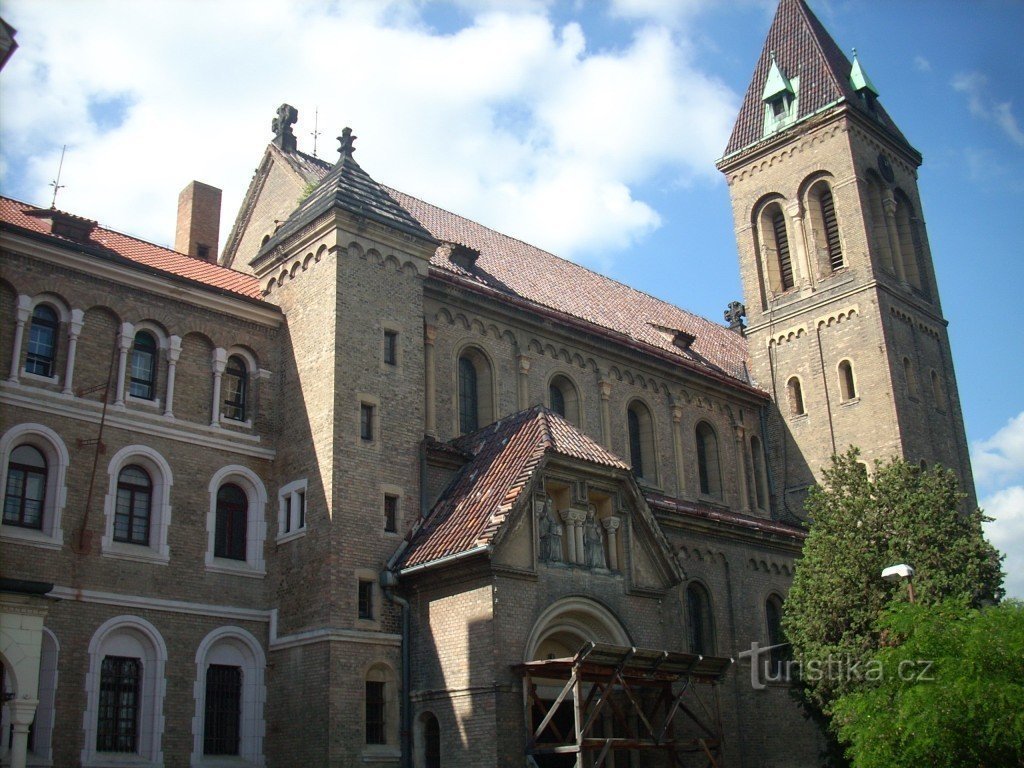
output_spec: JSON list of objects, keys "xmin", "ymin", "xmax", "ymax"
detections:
[{"xmin": 0, "ymin": 0, "xmax": 1024, "ymax": 598}]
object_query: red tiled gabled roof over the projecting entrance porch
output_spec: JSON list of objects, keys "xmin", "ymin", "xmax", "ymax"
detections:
[{"xmin": 397, "ymin": 406, "xmax": 629, "ymax": 568}]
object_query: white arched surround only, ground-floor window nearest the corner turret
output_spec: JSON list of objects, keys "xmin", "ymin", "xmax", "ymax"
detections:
[{"xmin": 191, "ymin": 627, "xmax": 266, "ymax": 768}]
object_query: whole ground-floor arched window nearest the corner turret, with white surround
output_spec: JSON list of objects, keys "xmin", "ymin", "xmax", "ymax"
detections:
[{"xmin": 191, "ymin": 627, "xmax": 266, "ymax": 765}]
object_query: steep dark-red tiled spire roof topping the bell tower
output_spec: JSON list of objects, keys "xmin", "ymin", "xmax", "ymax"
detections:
[{"xmin": 725, "ymin": 0, "xmax": 906, "ymax": 157}]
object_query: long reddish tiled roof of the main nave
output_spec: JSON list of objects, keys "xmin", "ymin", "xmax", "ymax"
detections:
[{"xmin": 288, "ymin": 153, "xmax": 749, "ymax": 384}]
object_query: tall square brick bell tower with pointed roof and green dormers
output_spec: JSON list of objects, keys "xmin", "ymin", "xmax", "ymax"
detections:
[{"xmin": 718, "ymin": 0, "xmax": 975, "ymax": 516}]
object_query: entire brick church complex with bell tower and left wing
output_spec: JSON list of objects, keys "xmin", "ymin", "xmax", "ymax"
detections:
[{"xmin": 0, "ymin": 0, "xmax": 974, "ymax": 768}]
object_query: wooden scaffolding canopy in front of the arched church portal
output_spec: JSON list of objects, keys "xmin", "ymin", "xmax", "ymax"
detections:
[{"xmin": 512, "ymin": 642, "xmax": 732, "ymax": 768}]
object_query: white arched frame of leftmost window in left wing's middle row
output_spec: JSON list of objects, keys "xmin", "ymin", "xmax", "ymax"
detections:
[{"xmin": 0, "ymin": 423, "xmax": 71, "ymax": 549}]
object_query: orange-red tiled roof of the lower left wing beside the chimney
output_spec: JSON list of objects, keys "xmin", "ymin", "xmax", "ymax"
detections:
[{"xmin": 0, "ymin": 197, "xmax": 262, "ymax": 299}]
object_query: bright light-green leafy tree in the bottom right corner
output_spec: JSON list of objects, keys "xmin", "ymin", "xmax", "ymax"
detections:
[{"xmin": 833, "ymin": 599, "xmax": 1024, "ymax": 768}]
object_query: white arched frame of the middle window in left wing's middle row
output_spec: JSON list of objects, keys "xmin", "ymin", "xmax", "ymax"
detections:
[{"xmin": 100, "ymin": 445, "xmax": 174, "ymax": 565}]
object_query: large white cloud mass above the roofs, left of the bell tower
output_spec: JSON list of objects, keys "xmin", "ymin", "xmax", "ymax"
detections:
[{"xmin": 0, "ymin": 0, "xmax": 738, "ymax": 260}]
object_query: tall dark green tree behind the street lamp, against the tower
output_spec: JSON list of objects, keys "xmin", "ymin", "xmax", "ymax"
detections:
[{"xmin": 782, "ymin": 449, "xmax": 1002, "ymax": 716}]
